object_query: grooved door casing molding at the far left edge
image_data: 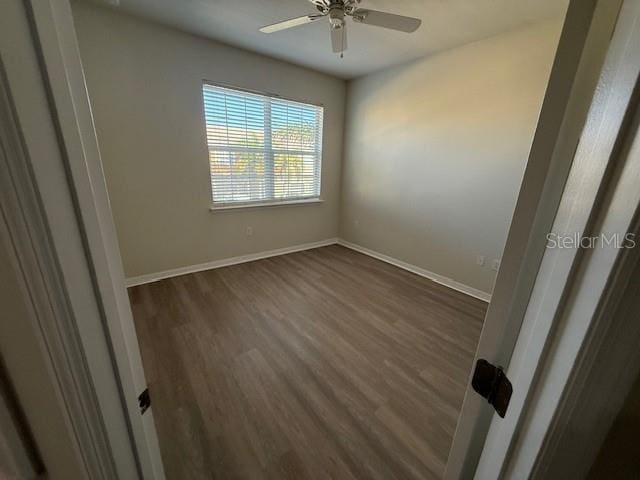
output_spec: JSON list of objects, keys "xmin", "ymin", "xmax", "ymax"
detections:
[{"xmin": 0, "ymin": 55, "xmax": 117, "ymax": 480}]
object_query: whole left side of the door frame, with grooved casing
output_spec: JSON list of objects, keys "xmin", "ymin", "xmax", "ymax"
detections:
[{"xmin": 0, "ymin": 0, "xmax": 164, "ymax": 480}]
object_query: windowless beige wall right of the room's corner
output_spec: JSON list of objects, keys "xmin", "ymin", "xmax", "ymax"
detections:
[{"xmin": 340, "ymin": 20, "xmax": 561, "ymax": 292}]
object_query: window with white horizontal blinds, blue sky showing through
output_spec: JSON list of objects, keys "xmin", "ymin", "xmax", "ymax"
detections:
[{"xmin": 202, "ymin": 84, "xmax": 323, "ymax": 208}]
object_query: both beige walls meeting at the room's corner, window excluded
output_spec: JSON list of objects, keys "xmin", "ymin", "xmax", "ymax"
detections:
[{"xmin": 74, "ymin": 2, "xmax": 561, "ymax": 292}]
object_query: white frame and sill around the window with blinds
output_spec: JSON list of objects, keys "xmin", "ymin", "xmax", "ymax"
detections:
[{"xmin": 200, "ymin": 79, "xmax": 325, "ymax": 212}]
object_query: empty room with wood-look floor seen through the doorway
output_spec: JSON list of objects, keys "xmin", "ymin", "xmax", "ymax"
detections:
[{"xmin": 72, "ymin": 0, "xmax": 567, "ymax": 479}]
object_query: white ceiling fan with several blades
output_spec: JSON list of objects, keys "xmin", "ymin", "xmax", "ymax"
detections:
[{"xmin": 260, "ymin": 0, "xmax": 422, "ymax": 57}]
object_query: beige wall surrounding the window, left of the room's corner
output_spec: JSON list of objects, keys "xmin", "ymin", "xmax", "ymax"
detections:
[{"xmin": 73, "ymin": 2, "xmax": 346, "ymax": 277}]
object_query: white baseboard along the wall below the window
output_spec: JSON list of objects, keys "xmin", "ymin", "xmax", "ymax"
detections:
[{"xmin": 125, "ymin": 238, "xmax": 338, "ymax": 287}]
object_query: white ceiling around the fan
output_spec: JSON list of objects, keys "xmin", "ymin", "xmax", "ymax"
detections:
[{"xmin": 94, "ymin": 0, "xmax": 568, "ymax": 78}]
